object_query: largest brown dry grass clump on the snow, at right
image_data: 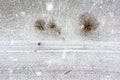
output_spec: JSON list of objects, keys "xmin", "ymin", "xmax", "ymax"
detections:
[{"xmin": 80, "ymin": 13, "xmax": 99, "ymax": 34}]
